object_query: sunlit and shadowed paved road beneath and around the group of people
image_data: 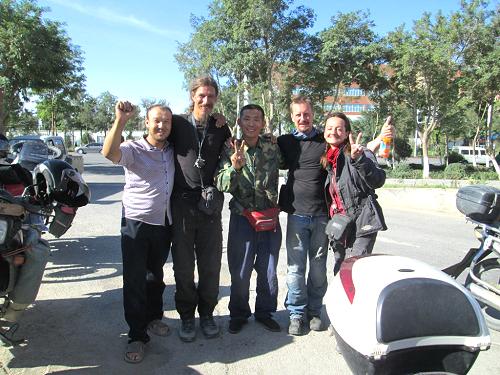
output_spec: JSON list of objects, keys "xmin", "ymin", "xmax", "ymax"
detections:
[{"xmin": 0, "ymin": 155, "xmax": 500, "ymax": 375}]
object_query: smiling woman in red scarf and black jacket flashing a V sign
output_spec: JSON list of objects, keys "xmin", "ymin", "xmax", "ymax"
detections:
[{"xmin": 321, "ymin": 112, "xmax": 387, "ymax": 273}]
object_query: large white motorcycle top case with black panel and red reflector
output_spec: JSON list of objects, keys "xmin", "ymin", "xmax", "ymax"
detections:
[{"xmin": 325, "ymin": 255, "xmax": 490, "ymax": 375}]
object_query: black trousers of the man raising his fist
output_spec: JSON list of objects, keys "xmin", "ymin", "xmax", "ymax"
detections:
[{"xmin": 121, "ymin": 218, "xmax": 172, "ymax": 342}]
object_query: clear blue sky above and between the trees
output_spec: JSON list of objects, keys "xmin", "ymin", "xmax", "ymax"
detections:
[{"xmin": 38, "ymin": 0, "xmax": 460, "ymax": 113}]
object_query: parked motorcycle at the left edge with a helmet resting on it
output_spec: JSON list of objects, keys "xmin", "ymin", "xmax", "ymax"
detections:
[{"xmin": 0, "ymin": 140, "xmax": 90, "ymax": 345}]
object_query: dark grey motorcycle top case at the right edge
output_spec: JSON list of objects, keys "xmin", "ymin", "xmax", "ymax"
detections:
[{"xmin": 456, "ymin": 185, "xmax": 500, "ymax": 223}]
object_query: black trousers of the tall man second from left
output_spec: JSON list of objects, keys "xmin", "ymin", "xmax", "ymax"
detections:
[{"xmin": 172, "ymin": 195, "xmax": 222, "ymax": 320}]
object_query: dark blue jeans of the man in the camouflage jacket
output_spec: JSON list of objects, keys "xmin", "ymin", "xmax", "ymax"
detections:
[{"xmin": 227, "ymin": 213, "xmax": 281, "ymax": 319}]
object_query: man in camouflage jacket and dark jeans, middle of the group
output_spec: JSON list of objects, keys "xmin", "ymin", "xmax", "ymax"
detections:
[{"xmin": 217, "ymin": 104, "xmax": 282, "ymax": 333}]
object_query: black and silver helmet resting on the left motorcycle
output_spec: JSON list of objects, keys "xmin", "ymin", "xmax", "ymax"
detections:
[{"xmin": 33, "ymin": 159, "xmax": 90, "ymax": 207}]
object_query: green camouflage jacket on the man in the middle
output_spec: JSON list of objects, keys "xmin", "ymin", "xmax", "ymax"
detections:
[{"xmin": 216, "ymin": 137, "xmax": 283, "ymax": 214}]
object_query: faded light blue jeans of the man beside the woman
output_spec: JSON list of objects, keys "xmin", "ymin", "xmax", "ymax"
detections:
[{"xmin": 285, "ymin": 214, "xmax": 328, "ymax": 318}]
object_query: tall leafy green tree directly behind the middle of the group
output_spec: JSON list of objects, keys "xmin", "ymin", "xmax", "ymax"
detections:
[{"xmin": 176, "ymin": 0, "xmax": 314, "ymax": 130}]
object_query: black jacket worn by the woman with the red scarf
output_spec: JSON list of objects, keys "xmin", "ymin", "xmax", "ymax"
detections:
[{"xmin": 325, "ymin": 148, "xmax": 387, "ymax": 237}]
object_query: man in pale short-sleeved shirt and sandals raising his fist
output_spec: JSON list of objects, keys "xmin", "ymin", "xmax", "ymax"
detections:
[{"xmin": 102, "ymin": 102, "xmax": 174, "ymax": 363}]
